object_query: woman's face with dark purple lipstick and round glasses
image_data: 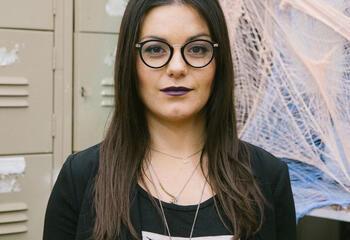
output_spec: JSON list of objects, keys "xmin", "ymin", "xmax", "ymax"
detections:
[{"xmin": 136, "ymin": 4, "xmax": 216, "ymax": 122}]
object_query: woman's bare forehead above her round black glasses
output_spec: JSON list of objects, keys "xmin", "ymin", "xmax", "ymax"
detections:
[{"xmin": 140, "ymin": 4, "xmax": 210, "ymax": 43}]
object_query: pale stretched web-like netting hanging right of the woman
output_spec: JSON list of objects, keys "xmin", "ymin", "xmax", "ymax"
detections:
[{"xmin": 220, "ymin": 0, "xmax": 350, "ymax": 218}]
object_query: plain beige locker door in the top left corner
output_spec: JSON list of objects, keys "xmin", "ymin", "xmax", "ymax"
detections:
[{"xmin": 0, "ymin": 0, "xmax": 54, "ymax": 30}]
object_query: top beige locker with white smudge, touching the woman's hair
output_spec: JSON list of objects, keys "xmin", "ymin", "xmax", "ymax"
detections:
[{"xmin": 75, "ymin": 0, "xmax": 127, "ymax": 33}]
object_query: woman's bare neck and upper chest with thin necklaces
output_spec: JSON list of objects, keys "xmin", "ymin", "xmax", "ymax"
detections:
[{"xmin": 139, "ymin": 112, "xmax": 213, "ymax": 205}]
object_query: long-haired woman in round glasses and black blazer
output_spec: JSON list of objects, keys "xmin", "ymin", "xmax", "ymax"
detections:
[{"xmin": 44, "ymin": 0, "xmax": 295, "ymax": 240}]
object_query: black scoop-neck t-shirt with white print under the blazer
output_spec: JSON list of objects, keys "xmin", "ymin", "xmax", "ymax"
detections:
[{"xmin": 137, "ymin": 185, "xmax": 233, "ymax": 240}]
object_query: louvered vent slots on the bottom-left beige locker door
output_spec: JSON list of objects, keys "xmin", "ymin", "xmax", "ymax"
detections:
[{"xmin": 0, "ymin": 203, "xmax": 28, "ymax": 236}]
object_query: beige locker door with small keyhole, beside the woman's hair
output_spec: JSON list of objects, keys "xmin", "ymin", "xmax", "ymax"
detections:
[{"xmin": 73, "ymin": 33, "xmax": 117, "ymax": 151}]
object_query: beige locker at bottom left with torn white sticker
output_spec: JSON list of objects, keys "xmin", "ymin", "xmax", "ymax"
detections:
[{"xmin": 0, "ymin": 155, "xmax": 52, "ymax": 240}]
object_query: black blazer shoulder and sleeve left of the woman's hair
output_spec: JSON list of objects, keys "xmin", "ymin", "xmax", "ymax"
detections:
[{"xmin": 43, "ymin": 144, "xmax": 100, "ymax": 239}]
